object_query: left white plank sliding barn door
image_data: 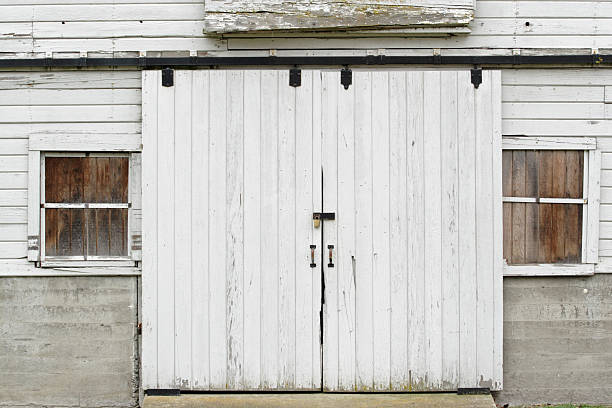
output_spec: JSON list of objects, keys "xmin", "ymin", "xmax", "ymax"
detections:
[{"xmin": 142, "ymin": 70, "xmax": 322, "ymax": 390}]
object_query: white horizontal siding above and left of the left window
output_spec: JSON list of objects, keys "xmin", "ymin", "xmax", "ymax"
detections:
[{"xmin": 0, "ymin": 71, "xmax": 141, "ymax": 258}]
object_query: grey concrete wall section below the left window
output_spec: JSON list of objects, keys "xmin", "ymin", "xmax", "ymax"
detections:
[{"xmin": 0, "ymin": 277, "xmax": 138, "ymax": 407}]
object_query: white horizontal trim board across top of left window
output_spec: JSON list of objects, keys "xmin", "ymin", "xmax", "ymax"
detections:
[{"xmin": 29, "ymin": 134, "xmax": 142, "ymax": 152}]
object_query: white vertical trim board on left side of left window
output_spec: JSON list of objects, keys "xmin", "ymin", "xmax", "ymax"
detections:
[{"xmin": 28, "ymin": 151, "xmax": 41, "ymax": 262}]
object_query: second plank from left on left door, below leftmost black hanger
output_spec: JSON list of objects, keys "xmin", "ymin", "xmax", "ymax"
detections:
[{"xmin": 157, "ymin": 72, "xmax": 176, "ymax": 388}]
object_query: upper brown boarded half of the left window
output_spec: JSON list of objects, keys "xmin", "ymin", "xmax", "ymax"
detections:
[{"xmin": 45, "ymin": 157, "xmax": 129, "ymax": 203}]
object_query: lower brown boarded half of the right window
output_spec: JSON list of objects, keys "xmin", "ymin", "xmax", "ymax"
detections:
[{"xmin": 504, "ymin": 203, "xmax": 583, "ymax": 265}]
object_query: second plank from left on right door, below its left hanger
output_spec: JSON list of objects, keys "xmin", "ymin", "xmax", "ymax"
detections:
[{"xmin": 338, "ymin": 69, "xmax": 356, "ymax": 391}]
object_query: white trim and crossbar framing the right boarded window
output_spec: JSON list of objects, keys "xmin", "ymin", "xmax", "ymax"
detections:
[{"xmin": 502, "ymin": 136, "xmax": 601, "ymax": 276}]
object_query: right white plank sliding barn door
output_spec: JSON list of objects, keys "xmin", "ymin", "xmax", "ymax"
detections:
[{"xmin": 322, "ymin": 71, "xmax": 502, "ymax": 391}]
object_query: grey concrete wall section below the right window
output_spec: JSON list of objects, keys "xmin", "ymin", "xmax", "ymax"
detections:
[{"xmin": 496, "ymin": 274, "xmax": 612, "ymax": 406}]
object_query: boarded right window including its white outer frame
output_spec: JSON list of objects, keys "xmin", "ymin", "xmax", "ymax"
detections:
[{"xmin": 502, "ymin": 137, "xmax": 600, "ymax": 270}]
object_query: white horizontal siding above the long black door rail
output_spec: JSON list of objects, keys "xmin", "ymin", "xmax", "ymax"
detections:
[{"xmin": 0, "ymin": 0, "xmax": 612, "ymax": 57}]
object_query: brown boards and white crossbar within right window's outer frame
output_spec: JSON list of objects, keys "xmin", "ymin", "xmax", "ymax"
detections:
[{"xmin": 503, "ymin": 150, "xmax": 587, "ymax": 264}]
